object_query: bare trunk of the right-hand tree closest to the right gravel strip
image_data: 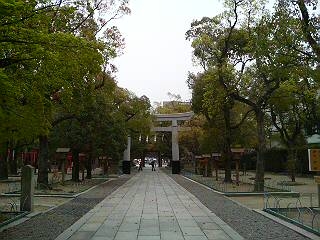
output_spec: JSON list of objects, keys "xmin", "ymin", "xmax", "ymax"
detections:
[{"xmin": 254, "ymin": 109, "xmax": 266, "ymax": 192}]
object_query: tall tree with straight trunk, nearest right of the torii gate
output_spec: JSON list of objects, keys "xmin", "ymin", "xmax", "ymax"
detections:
[{"xmin": 186, "ymin": 0, "xmax": 263, "ymax": 182}]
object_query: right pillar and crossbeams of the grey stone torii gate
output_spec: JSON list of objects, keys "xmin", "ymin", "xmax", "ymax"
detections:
[{"xmin": 151, "ymin": 112, "xmax": 194, "ymax": 174}]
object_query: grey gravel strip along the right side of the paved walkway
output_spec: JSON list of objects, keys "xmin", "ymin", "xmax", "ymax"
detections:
[{"xmin": 168, "ymin": 174, "xmax": 309, "ymax": 240}]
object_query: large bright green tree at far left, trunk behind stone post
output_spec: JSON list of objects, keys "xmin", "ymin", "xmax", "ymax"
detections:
[{"xmin": 0, "ymin": 1, "xmax": 129, "ymax": 184}]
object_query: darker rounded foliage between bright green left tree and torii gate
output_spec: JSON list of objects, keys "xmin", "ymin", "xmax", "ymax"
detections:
[{"xmin": 51, "ymin": 78, "xmax": 151, "ymax": 161}]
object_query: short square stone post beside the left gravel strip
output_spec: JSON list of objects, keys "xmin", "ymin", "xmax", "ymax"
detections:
[{"xmin": 20, "ymin": 165, "xmax": 34, "ymax": 212}]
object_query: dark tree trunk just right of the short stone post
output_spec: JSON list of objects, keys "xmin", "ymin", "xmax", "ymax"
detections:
[{"xmin": 38, "ymin": 135, "xmax": 49, "ymax": 188}]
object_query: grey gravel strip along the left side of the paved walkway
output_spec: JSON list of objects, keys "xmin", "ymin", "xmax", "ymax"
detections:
[{"xmin": 0, "ymin": 175, "xmax": 130, "ymax": 240}]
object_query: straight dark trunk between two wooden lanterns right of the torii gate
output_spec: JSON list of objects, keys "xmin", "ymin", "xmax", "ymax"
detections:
[{"xmin": 223, "ymin": 106, "xmax": 232, "ymax": 182}]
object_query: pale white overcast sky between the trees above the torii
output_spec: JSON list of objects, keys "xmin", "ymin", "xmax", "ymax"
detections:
[{"xmin": 114, "ymin": 0, "xmax": 222, "ymax": 104}]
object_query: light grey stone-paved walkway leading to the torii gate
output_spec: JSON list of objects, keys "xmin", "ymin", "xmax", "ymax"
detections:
[{"xmin": 57, "ymin": 168, "xmax": 243, "ymax": 240}]
